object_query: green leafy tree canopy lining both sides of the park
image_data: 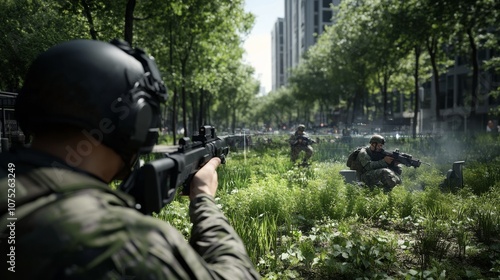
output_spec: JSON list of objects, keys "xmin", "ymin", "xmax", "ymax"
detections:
[{"xmin": 0, "ymin": 0, "xmax": 500, "ymax": 136}]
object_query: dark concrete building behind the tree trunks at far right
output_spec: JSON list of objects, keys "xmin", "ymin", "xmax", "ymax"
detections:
[{"xmin": 418, "ymin": 49, "xmax": 500, "ymax": 132}]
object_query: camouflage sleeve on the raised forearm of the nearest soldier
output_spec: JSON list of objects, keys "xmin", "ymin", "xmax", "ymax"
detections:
[{"xmin": 190, "ymin": 195, "xmax": 260, "ymax": 279}]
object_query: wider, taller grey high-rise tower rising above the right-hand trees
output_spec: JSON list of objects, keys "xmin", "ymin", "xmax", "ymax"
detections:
[{"xmin": 284, "ymin": 0, "xmax": 341, "ymax": 84}]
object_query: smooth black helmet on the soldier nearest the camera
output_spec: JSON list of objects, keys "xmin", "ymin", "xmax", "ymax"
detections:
[{"xmin": 16, "ymin": 39, "xmax": 167, "ymax": 164}]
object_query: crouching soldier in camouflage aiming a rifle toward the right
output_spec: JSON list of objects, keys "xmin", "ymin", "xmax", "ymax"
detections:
[{"xmin": 357, "ymin": 135, "xmax": 402, "ymax": 192}]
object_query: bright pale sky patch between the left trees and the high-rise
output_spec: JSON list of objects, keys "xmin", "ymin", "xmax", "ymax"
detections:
[{"xmin": 243, "ymin": 0, "xmax": 285, "ymax": 93}]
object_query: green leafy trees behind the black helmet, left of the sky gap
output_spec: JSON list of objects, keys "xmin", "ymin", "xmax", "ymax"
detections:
[{"xmin": 0, "ymin": 0, "xmax": 254, "ymax": 131}]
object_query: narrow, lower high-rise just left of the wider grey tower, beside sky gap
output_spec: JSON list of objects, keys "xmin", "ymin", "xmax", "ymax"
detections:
[{"xmin": 271, "ymin": 18, "xmax": 285, "ymax": 91}]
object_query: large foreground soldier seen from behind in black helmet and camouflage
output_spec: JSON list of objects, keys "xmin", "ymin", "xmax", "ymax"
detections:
[{"xmin": 0, "ymin": 40, "xmax": 260, "ymax": 279}]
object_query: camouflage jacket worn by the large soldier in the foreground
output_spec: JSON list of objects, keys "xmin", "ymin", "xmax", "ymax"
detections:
[{"xmin": 0, "ymin": 153, "xmax": 260, "ymax": 279}]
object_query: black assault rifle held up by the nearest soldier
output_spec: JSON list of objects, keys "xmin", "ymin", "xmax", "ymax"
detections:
[{"xmin": 119, "ymin": 126, "xmax": 229, "ymax": 214}]
